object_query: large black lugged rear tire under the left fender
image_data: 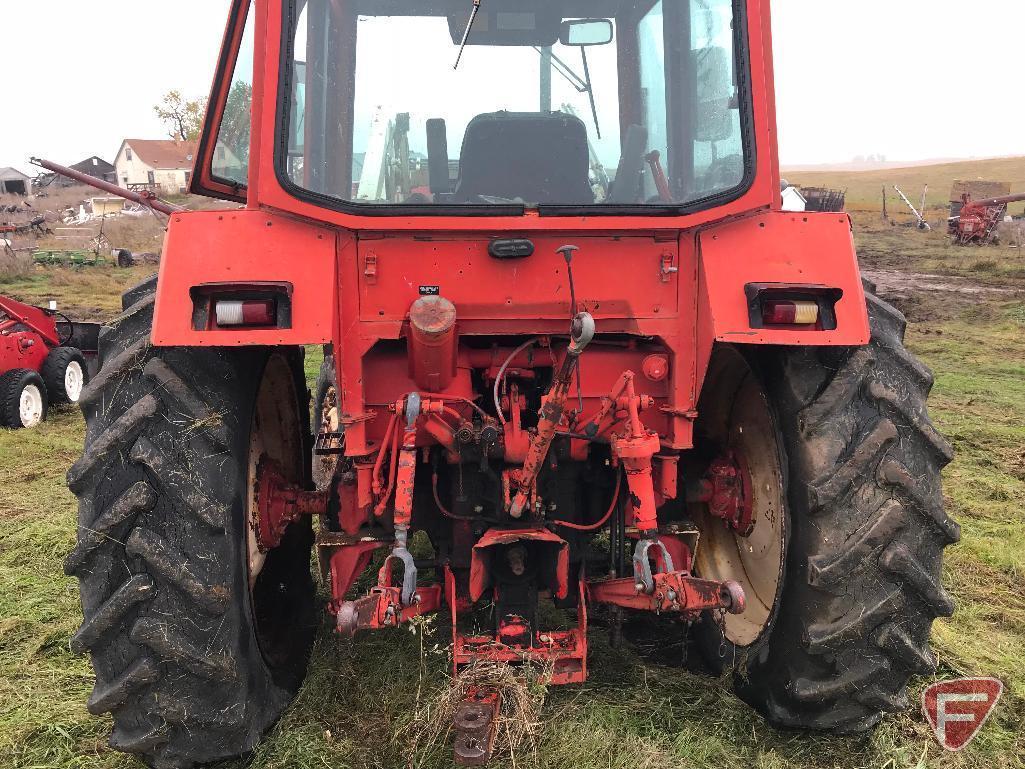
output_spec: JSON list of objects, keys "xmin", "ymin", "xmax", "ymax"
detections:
[{"xmin": 65, "ymin": 288, "xmax": 316, "ymax": 767}]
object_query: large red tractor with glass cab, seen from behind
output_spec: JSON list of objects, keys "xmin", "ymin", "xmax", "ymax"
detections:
[{"xmin": 67, "ymin": 0, "xmax": 959, "ymax": 767}]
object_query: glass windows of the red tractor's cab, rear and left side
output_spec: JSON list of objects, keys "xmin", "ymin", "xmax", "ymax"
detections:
[{"xmin": 197, "ymin": 0, "xmax": 755, "ymax": 222}]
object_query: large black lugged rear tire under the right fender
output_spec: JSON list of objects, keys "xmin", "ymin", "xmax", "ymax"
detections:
[{"xmin": 737, "ymin": 294, "xmax": 960, "ymax": 733}]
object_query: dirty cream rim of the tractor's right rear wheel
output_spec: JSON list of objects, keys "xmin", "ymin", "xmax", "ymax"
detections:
[{"xmin": 694, "ymin": 353, "xmax": 786, "ymax": 646}]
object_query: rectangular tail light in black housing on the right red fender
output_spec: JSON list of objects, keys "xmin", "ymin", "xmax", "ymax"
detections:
[{"xmin": 744, "ymin": 283, "xmax": 844, "ymax": 331}]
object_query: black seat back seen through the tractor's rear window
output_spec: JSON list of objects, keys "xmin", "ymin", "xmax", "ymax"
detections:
[{"xmin": 455, "ymin": 112, "xmax": 595, "ymax": 205}]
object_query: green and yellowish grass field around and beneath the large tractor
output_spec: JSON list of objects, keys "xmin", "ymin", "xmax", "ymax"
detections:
[{"xmin": 0, "ymin": 169, "xmax": 1025, "ymax": 769}]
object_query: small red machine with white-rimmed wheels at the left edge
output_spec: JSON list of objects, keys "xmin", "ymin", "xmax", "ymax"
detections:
[{"xmin": 0, "ymin": 296, "xmax": 98, "ymax": 430}]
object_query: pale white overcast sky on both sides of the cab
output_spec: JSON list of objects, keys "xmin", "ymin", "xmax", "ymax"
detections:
[{"xmin": 0, "ymin": 0, "xmax": 1025, "ymax": 170}]
